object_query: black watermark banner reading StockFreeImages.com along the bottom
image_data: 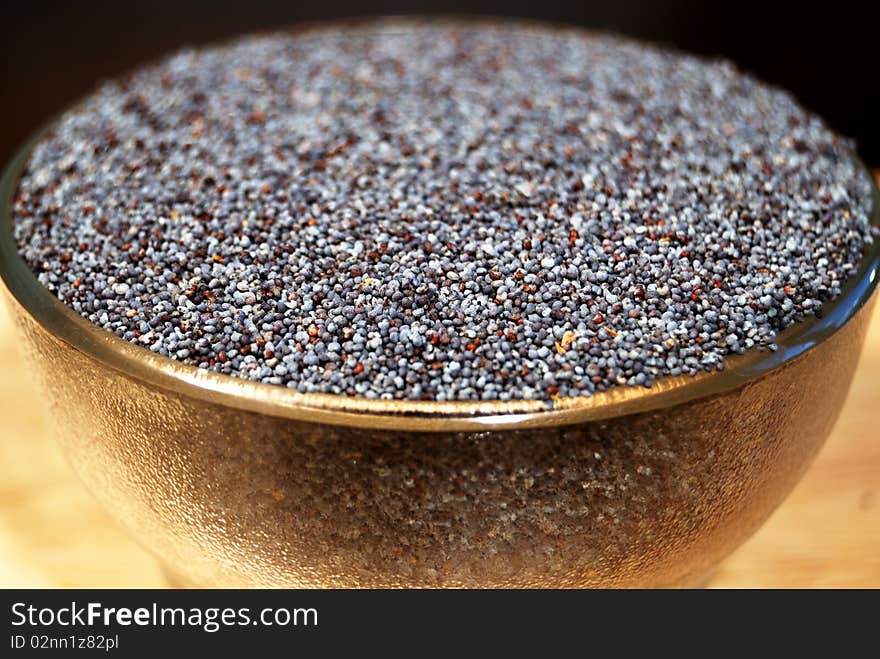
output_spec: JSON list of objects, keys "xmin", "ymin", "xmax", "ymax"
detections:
[{"xmin": 0, "ymin": 589, "xmax": 877, "ymax": 659}]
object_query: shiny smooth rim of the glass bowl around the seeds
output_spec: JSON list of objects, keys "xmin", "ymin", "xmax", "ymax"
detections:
[{"xmin": 0, "ymin": 45, "xmax": 880, "ymax": 432}]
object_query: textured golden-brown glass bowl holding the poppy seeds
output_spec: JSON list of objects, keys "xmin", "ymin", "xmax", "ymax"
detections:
[{"xmin": 0, "ymin": 129, "xmax": 880, "ymax": 587}]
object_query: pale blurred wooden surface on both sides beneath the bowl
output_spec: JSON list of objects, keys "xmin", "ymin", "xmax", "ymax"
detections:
[{"xmin": 0, "ymin": 292, "xmax": 880, "ymax": 587}]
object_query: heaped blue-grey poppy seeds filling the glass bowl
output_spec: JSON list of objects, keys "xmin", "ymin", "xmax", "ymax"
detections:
[{"xmin": 14, "ymin": 23, "xmax": 872, "ymax": 404}]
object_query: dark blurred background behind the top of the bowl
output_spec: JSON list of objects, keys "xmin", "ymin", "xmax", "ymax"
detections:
[{"xmin": 0, "ymin": 0, "xmax": 880, "ymax": 166}]
